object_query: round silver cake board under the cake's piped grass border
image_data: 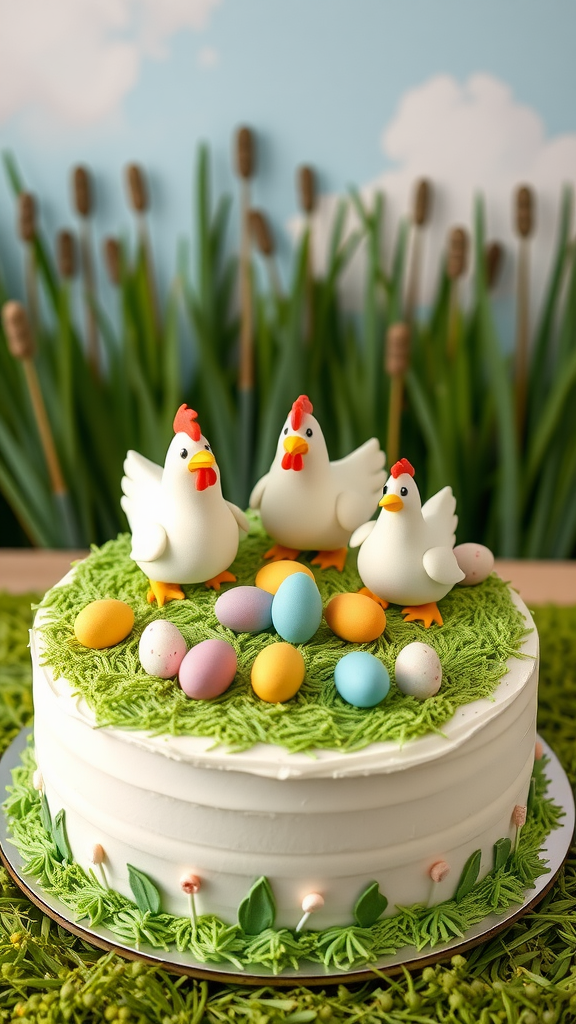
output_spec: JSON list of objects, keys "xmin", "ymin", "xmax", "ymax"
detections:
[{"xmin": 0, "ymin": 729, "xmax": 575, "ymax": 986}]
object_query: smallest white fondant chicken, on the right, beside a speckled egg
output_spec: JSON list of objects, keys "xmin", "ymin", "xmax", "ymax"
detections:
[{"xmin": 351, "ymin": 459, "xmax": 464, "ymax": 629}]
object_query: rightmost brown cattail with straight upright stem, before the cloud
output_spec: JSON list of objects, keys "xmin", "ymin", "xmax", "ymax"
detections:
[{"xmin": 515, "ymin": 185, "xmax": 534, "ymax": 444}]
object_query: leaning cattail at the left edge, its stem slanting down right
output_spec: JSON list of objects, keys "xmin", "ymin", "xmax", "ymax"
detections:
[{"xmin": 2, "ymin": 302, "xmax": 79, "ymax": 548}]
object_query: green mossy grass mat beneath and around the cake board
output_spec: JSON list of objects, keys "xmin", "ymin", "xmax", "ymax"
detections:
[{"xmin": 0, "ymin": 595, "xmax": 576, "ymax": 1024}]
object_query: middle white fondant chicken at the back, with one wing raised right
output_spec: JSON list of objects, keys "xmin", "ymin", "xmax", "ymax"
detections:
[{"xmin": 250, "ymin": 394, "xmax": 386, "ymax": 570}]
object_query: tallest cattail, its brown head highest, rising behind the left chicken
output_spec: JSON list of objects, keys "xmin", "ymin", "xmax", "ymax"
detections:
[{"xmin": 236, "ymin": 127, "xmax": 256, "ymax": 504}]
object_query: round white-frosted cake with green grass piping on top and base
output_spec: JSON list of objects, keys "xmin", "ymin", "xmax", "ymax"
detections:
[{"xmin": 2, "ymin": 513, "xmax": 553, "ymax": 972}]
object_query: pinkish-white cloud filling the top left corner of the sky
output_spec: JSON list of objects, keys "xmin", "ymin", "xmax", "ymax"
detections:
[{"xmin": 0, "ymin": 0, "xmax": 219, "ymax": 126}]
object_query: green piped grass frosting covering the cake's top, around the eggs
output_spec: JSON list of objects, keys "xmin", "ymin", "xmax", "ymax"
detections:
[{"xmin": 36, "ymin": 514, "xmax": 526, "ymax": 753}]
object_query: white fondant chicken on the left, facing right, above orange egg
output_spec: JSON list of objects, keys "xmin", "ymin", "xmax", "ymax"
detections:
[{"xmin": 121, "ymin": 406, "xmax": 249, "ymax": 607}]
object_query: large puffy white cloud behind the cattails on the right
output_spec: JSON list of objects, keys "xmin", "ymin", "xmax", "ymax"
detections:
[{"xmin": 291, "ymin": 75, "xmax": 576, "ymax": 313}]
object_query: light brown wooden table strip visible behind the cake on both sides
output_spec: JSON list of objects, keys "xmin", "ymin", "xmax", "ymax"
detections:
[{"xmin": 0, "ymin": 548, "xmax": 576, "ymax": 604}]
